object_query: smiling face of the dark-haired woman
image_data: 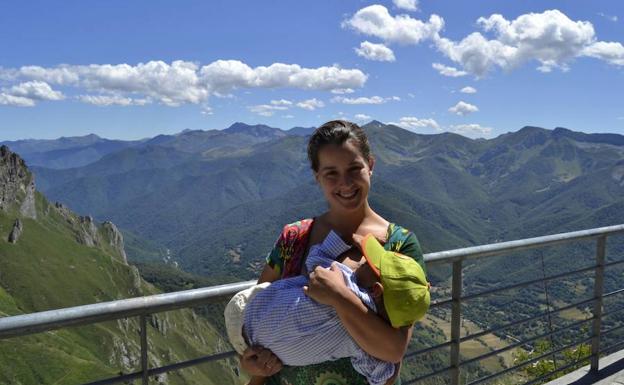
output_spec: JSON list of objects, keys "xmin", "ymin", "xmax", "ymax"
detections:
[{"xmin": 315, "ymin": 140, "xmax": 373, "ymax": 211}]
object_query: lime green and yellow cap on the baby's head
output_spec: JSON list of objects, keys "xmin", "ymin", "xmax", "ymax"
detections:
[{"xmin": 361, "ymin": 234, "xmax": 431, "ymax": 328}]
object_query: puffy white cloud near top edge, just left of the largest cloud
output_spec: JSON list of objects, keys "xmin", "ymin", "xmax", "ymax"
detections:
[{"xmin": 342, "ymin": 4, "xmax": 444, "ymax": 44}]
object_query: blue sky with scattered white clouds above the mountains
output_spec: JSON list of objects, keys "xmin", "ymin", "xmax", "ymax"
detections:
[{"xmin": 0, "ymin": 0, "xmax": 624, "ymax": 141}]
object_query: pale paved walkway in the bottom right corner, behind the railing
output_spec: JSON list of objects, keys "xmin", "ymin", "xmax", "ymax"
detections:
[{"xmin": 546, "ymin": 350, "xmax": 624, "ymax": 385}]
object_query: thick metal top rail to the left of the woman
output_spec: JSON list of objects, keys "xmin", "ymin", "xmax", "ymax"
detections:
[{"xmin": 0, "ymin": 281, "xmax": 256, "ymax": 339}]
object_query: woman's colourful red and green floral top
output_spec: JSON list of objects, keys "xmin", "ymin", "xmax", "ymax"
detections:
[{"xmin": 266, "ymin": 219, "xmax": 425, "ymax": 385}]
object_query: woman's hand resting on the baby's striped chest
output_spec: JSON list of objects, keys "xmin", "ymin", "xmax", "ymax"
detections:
[{"xmin": 303, "ymin": 262, "xmax": 351, "ymax": 307}]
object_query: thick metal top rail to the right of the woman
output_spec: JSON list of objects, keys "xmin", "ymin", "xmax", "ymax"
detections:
[{"xmin": 424, "ymin": 224, "xmax": 624, "ymax": 264}]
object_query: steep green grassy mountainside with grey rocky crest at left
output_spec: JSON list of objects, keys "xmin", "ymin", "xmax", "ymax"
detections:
[{"xmin": 0, "ymin": 146, "xmax": 237, "ymax": 385}]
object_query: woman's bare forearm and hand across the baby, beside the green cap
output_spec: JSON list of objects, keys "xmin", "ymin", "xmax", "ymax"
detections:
[{"xmin": 304, "ymin": 264, "xmax": 412, "ymax": 363}]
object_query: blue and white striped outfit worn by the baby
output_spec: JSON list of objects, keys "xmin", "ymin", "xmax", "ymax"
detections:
[{"xmin": 244, "ymin": 231, "xmax": 395, "ymax": 385}]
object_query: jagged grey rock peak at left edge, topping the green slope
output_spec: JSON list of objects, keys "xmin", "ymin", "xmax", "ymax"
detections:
[{"xmin": 0, "ymin": 146, "xmax": 37, "ymax": 219}]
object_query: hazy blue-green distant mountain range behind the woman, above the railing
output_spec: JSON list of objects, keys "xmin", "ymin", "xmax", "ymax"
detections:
[{"xmin": 6, "ymin": 121, "xmax": 624, "ymax": 279}]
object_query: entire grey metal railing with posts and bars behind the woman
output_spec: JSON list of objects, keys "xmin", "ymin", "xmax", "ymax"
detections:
[{"xmin": 0, "ymin": 224, "xmax": 624, "ymax": 385}]
